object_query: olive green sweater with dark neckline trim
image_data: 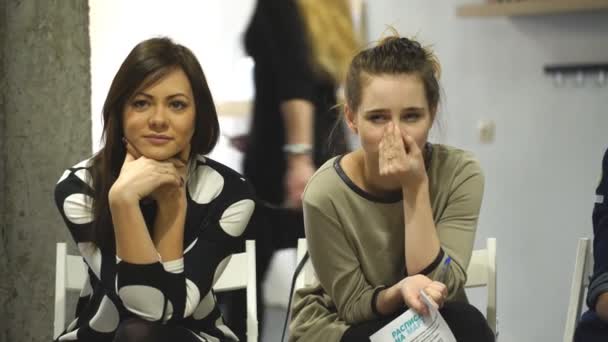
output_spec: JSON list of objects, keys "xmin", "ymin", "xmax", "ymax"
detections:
[{"xmin": 290, "ymin": 144, "xmax": 484, "ymax": 342}]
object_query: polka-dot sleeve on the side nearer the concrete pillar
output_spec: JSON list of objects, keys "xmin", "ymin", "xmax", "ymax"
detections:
[{"xmin": 55, "ymin": 166, "xmax": 186, "ymax": 321}]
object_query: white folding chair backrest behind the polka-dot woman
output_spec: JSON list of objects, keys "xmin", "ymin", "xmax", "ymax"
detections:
[{"xmin": 53, "ymin": 240, "xmax": 258, "ymax": 342}]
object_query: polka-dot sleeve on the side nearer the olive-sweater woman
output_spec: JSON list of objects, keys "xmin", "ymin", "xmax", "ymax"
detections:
[{"xmin": 117, "ymin": 163, "xmax": 255, "ymax": 320}]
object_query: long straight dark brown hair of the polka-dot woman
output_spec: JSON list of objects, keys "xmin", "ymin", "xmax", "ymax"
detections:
[{"xmin": 91, "ymin": 38, "xmax": 220, "ymax": 248}]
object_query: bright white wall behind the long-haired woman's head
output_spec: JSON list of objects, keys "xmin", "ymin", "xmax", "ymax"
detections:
[{"xmin": 89, "ymin": 0, "xmax": 255, "ymax": 150}]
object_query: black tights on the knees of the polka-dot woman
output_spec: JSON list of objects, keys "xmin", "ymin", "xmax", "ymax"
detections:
[{"xmin": 113, "ymin": 318, "xmax": 200, "ymax": 342}]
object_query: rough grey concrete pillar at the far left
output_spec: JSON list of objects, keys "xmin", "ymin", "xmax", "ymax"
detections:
[{"xmin": 0, "ymin": 0, "xmax": 91, "ymax": 342}]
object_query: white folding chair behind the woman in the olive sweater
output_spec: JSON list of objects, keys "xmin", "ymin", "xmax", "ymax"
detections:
[{"xmin": 295, "ymin": 238, "xmax": 498, "ymax": 336}]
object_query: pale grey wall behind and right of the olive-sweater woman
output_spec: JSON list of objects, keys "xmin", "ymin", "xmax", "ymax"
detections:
[{"xmin": 369, "ymin": 0, "xmax": 608, "ymax": 342}]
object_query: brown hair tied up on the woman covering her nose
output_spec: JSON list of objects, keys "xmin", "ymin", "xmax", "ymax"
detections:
[{"xmin": 345, "ymin": 35, "xmax": 441, "ymax": 115}]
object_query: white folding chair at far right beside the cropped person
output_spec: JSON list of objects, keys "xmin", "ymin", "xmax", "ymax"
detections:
[{"xmin": 564, "ymin": 238, "xmax": 593, "ymax": 342}]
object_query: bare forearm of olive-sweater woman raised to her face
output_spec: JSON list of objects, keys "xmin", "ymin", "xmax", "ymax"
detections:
[{"xmin": 403, "ymin": 181, "xmax": 441, "ymax": 275}]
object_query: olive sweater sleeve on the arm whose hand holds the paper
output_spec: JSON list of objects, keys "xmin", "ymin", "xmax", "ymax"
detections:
[{"xmin": 304, "ymin": 200, "xmax": 384, "ymax": 324}]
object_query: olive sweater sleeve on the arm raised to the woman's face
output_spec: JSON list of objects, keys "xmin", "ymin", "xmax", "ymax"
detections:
[{"xmin": 425, "ymin": 156, "xmax": 484, "ymax": 298}]
